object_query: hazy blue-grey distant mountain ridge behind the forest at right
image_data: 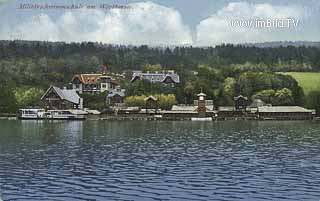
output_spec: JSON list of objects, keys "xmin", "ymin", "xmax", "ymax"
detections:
[{"xmin": 242, "ymin": 41, "xmax": 320, "ymax": 48}]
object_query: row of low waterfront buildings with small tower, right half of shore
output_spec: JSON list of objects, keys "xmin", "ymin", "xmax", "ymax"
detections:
[{"xmin": 160, "ymin": 93, "xmax": 316, "ymax": 120}]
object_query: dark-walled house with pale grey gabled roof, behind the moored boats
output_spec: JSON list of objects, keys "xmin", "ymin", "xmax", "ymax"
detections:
[{"xmin": 41, "ymin": 86, "xmax": 83, "ymax": 109}]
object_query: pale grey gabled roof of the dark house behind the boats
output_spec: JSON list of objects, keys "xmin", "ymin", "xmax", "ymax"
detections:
[{"xmin": 41, "ymin": 86, "xmax": 81, "ymax": 104}]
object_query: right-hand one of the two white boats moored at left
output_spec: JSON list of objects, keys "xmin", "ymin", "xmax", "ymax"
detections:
[{"xmin": 45, "ymin": 110, "xmax": 86, "ymax": 120}]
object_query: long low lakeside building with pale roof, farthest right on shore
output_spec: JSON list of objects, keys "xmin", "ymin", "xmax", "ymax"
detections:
[{"xmin": 258, "ymin": 106, "xmax": 315, "ymax": 120}]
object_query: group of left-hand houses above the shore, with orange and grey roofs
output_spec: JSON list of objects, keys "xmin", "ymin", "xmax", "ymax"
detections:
[{"xmin": 41, "ymin": 70, "xmax": 180, "ymax": 109}]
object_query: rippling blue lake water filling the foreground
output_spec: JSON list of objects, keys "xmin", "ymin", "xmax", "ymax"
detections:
[{"xmin": 0, "ymin": 120, "xmax": 320, "ymax": 201}]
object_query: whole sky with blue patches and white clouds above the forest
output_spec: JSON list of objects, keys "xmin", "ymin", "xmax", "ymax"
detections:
[{"xmin": 0, "ymin": 0, "xmax": 320, "ymax": 46}]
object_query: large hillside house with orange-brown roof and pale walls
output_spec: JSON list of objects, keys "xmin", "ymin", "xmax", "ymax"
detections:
[{"xmin": 71, "ymin": 74, "xmax": 118, "ymax": 94}]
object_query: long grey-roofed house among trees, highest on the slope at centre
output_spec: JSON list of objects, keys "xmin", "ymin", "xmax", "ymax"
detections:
[{"xmin": 131, "ymin": 70, "xmax": 180, "ymax": 85}]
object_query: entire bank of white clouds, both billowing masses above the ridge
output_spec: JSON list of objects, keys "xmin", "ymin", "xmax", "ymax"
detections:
[{"xmin": 0, "ymin": 0, "xmax": 307, "ymax": 46}]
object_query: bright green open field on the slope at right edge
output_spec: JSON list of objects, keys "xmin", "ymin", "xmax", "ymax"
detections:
[{"xmin": 284, "ymin": 72, "xmax": 320, "ymax": 95}]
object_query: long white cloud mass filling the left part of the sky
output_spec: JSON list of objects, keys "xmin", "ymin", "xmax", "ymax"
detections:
[{"xmin": 0, "ymin": 2, "xmax": 192, "ymax": 45}]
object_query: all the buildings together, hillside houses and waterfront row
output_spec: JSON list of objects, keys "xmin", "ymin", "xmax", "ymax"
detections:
[{"xmin": 36, "ymin": 68, "xmax": 315, "ymax": 120}]
